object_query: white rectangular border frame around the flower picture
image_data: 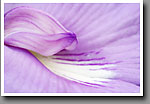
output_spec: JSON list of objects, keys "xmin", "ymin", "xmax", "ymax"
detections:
[{"xmin": 1, "ymin": 0, "xmax": 143, "ymax": 96}]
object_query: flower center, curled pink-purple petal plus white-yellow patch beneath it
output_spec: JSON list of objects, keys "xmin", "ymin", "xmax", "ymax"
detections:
[{"xmin": 4, "ymin": 7, "xmax": 115, "ymax": 85}]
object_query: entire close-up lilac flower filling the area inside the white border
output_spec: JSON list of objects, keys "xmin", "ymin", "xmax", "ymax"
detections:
[{"xmin": 4, "ymin": 3, "xmax": 140, "ymax": 93}]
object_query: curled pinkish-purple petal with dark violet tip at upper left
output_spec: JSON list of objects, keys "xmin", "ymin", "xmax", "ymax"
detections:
[{"xmin": 5, "ymin": 7, "xmax": 77, "ymax": 56}]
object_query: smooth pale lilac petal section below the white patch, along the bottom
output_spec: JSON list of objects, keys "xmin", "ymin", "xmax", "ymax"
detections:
[{"xmin": 4, "ymin": 46, "xmax": 139, "ymax": 93}]
